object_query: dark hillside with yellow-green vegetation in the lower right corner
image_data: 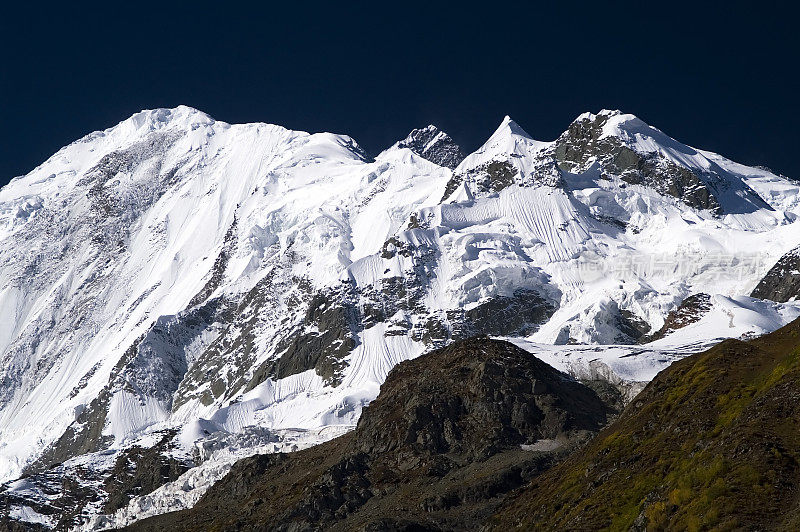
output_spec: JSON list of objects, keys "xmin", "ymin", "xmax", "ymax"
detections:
[{"xmin": 489, "ymin": 320, "xmax": 800, "ymax": 530}]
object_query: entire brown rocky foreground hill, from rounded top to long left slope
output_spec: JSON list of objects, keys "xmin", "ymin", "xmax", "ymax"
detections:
[{"xmin": 125, "ymin": 338, "xmax": 613, "ymax": 530}]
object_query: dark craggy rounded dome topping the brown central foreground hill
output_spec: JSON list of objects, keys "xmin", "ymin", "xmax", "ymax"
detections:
[{"xmin": 355, "ymin": 338, "xmax": 607, "ymax": 459}]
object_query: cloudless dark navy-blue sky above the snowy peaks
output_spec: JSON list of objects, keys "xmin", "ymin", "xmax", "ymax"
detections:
[{"xmin": 0, "ymin": 1, "xmax": 800, "ymax": 184}]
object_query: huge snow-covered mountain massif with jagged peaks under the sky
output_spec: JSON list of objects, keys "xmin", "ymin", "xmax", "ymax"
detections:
[{"xmin": 0, "ymin": 107, "xmax": 800, "ymax": 526}]
